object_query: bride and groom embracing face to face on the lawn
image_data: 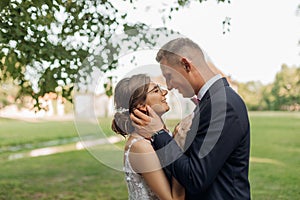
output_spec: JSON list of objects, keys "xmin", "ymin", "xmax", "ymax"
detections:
[{"xmin": 112, "ymin": 38, "xmax": 250, "ymax": 200}]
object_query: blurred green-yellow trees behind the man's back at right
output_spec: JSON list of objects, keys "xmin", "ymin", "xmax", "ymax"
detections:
[{"xmin": 238, "ymin": 65, "xmax": 300, "ymax": 111}]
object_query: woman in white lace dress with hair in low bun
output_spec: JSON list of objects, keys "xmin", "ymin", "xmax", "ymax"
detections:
[{"xmin": 112, "ymin": 74, "xmax": 185, "ymax": 200}]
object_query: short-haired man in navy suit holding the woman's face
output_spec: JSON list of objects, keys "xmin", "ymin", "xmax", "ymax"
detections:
[{"xmin": 131, "ymin": 38, "xmax": 250, "ymax": 200}]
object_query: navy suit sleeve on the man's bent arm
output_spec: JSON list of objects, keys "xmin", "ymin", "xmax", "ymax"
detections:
[{"xmin": 153, "ymin": 99, "xmax": 245, "ymax": 193}]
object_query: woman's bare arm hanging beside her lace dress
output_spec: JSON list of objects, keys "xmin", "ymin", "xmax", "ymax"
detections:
[{"xmin": 129, "ymin": 140, "xmax": 184, "ymax": 200}]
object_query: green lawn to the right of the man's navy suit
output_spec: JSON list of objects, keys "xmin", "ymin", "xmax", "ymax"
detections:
[{"xmin": 250, "ymin": 112, "xmax": 300, "ymax": 200}]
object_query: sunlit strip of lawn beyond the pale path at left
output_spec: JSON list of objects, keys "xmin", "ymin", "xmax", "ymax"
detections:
[{"xmin": 0, "ymin": 118, "xmax": 119, "ymax": 149}]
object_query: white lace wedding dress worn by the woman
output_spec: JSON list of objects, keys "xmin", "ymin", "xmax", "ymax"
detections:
[{"xmin": 124, "ymin": 137, "xmax": 159, "ymax": 200}]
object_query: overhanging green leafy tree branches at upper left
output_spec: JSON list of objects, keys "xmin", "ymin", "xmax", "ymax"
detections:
[{"xmin": 0, "ymin": 0, "xmax": 230, "ymax": 108}]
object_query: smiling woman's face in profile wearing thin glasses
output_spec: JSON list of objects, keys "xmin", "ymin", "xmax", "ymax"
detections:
[{"xmin": 146, "ymin": 82, "xmax": 170, "ymax": 116}]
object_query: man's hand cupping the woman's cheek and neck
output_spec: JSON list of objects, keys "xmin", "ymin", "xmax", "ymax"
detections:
[{"xmin": 130, "ymin": 105, "xmax": 164, "ymax": 139}]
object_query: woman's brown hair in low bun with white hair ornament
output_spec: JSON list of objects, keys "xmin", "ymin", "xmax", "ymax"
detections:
[{"xmin": 112, "ymin": 74, "xmax": 150, "ymax": 137}]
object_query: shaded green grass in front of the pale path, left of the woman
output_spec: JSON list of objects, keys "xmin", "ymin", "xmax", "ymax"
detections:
[{"xmin": 0, "ymin": 150, "xmax": 127, "ymax": 200}]
